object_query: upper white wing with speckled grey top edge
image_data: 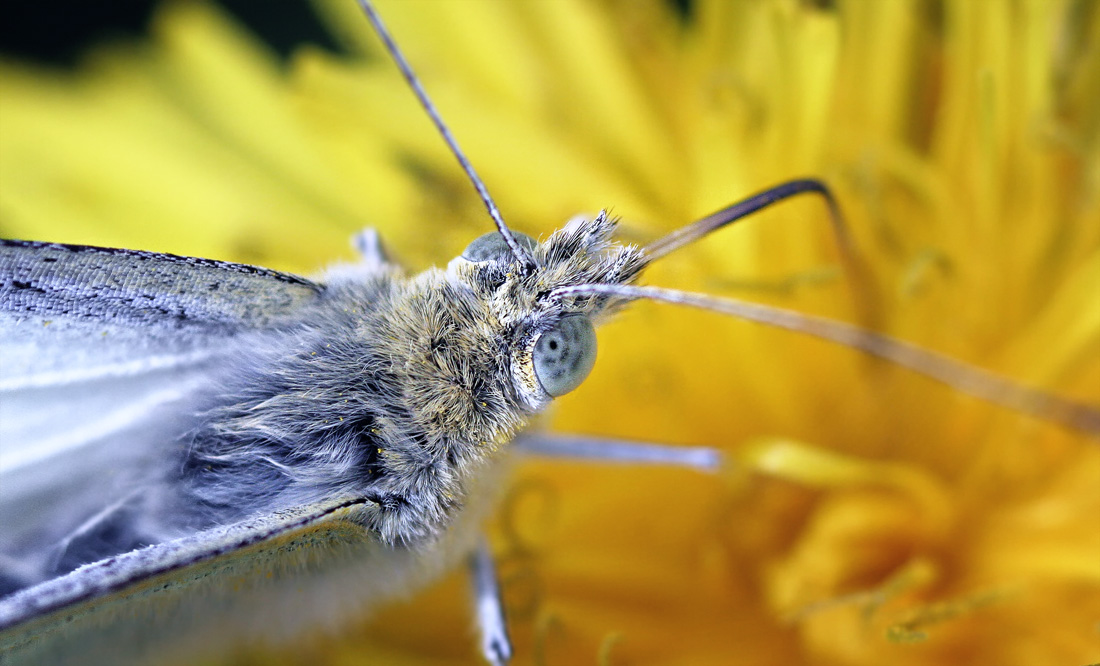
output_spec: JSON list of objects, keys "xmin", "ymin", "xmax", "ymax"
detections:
[{"xmin": 0, "ymin": 241, "xmax": 323, "ymax": 592}]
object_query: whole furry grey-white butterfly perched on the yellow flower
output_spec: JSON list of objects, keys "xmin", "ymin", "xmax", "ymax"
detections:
[{"xmin": 2, "ymin": 1, "xmax": 1093, "ymax": 658}]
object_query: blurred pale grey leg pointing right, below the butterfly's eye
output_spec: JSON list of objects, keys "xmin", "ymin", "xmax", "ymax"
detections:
[{"xmin": 513, "ymin": 433, "xmax": 724, "ymax": 472}]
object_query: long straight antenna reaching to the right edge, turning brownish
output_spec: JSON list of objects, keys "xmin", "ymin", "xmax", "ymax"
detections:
[{"xmin": 549, "ymin": 284, "xmax": 1100, "ymax": 435}]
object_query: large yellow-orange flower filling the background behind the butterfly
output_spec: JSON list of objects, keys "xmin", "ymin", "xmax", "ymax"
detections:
[{"xmin": 0, "ymin": 0, "xmax": 1100, "ymax": 664}]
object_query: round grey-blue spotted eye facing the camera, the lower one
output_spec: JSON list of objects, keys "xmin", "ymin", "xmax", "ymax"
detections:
[{"xmin": 531, "ymin": 315, "xmax": 596, "ymax": 397}]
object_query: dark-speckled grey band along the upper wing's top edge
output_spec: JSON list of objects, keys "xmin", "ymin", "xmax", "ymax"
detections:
[{"xmin": 0, "ymin": 240, "xmax": 323, "ymax": 329}]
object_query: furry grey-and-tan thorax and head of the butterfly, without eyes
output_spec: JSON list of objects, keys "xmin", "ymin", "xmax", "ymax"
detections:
[{"xmin": 182, "ymin": 215, "xmax": 645, "ymax": 544}]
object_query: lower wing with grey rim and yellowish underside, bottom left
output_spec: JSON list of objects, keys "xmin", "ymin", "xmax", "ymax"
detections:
[{"xmin": 0, "ymin": 499, "xmax": 378, "ymax": 663}]
